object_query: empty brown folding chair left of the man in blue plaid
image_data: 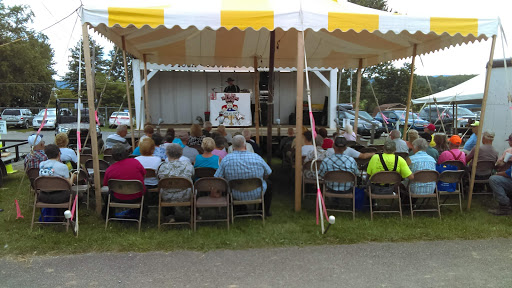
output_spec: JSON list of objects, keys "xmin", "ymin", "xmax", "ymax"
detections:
[{"xmin": 194, "ymin": 177, "xmax": 229, "ymax": 231}]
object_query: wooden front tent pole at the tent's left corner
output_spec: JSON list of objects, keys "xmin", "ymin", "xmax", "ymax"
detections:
[{"xmin": 78, "ymin": 23, "xmax": 102, "ymax": 214}]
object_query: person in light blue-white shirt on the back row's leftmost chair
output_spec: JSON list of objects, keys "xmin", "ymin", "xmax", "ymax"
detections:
[{"xmin": 37, "ymin": 144, "xmax": 76, "ymax": 204}]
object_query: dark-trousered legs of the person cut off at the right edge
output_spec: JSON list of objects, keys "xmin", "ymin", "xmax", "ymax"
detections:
[{"xmin": 489, "ymin": 168, "xmax": 512, "ymax": 215}]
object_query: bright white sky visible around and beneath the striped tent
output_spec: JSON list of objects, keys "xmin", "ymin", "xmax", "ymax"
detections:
[{"xmin": 3, "ymin": 0, "xmax": 512, "ymax": 78}]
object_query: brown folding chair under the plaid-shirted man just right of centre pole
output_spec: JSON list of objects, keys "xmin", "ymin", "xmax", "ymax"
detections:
[{"xmin": 323, "ymin": 171, "xmax": 357, "ymax": 220}]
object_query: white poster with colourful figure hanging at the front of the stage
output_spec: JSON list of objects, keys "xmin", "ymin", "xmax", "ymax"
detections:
[{"xmin": 210, "ymin": 93, "xmax": 252, "ymax": 127}]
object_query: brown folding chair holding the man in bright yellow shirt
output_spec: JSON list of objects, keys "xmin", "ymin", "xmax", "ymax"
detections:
[{"xmin": 366, "ymin": 171, "xmax": 402, "ymax": 221}]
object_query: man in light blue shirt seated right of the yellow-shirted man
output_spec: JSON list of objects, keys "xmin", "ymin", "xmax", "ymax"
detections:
[{"xmin": 409, "ymin": 138, "xmax": 436, "ymax": 195}]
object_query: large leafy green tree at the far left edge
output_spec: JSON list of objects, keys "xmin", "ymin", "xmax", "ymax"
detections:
[{"xmin": 0, "ymin": 2, "xmax": 55, "ymax": 106}]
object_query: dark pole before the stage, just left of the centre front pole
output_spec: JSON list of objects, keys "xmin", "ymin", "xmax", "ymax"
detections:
[{"xmin": 267, "ymin": 31, "xmax": 276, "ymax": 167}]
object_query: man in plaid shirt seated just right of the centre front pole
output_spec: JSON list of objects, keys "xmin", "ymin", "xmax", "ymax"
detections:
[{"xmin": 318, "ymin": 137, "xmax": 359, "ymax": 193}]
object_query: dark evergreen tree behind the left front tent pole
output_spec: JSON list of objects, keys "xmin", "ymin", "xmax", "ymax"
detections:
[{"xmin": 62, "ymin": 36, "xmax": 106, "ymax": 93}]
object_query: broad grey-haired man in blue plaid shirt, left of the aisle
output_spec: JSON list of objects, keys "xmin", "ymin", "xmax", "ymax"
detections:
[{"xmin": 215, "ymin": 135, "xmax": 272, "ymax": 216}]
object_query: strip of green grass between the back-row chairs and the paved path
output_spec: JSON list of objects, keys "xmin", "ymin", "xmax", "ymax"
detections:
[{"xmin": 0, "ymin": 161, "xmax": 512, "ymax": 256}]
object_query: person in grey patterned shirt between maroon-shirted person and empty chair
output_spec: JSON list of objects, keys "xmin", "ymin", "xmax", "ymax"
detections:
[{"xmin": 157, "ymin": 143, "xmax": 194, "ymax": 222}]
